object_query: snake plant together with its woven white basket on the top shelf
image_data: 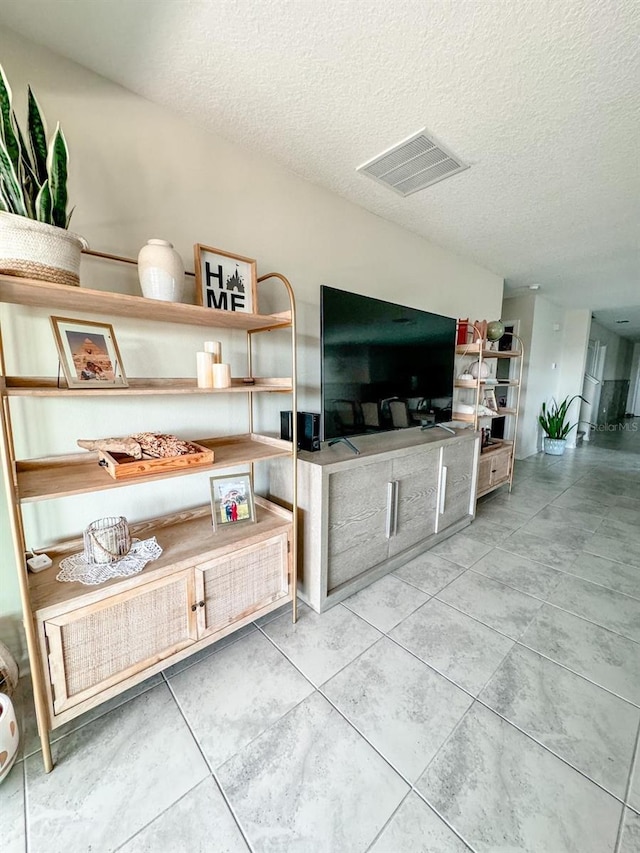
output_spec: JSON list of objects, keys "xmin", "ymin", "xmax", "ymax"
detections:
[{"xmin": 0, "ymin": 65, "xmax": 87, "ymax": 286}]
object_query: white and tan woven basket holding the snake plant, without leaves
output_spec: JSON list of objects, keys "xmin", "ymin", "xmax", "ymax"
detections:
[{"xmin": 0, "ymin": 212, "xmax": 88, "ymax": 287}]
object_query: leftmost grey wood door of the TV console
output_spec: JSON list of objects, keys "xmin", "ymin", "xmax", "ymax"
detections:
[{"xmin": 328, "ymin": 462, "xmax": 392, "ymax": 591}]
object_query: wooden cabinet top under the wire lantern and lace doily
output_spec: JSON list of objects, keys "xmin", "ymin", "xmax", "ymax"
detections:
[{"xmin": 29, "ymin": 498, "xmax": 291, "ymax": 618}]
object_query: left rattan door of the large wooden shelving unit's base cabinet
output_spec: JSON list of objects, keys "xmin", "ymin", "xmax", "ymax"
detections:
[{"xmin": 44, "ymin": 569, "xmax": 197, "ymax": 714}]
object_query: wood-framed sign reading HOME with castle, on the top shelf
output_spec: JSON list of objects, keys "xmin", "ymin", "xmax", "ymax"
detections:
[{"xmin": 193, "ymin": 243, "xmax": 258, "ymax": 314}]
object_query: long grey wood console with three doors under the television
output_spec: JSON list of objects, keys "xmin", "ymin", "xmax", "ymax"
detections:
[{"xmin": 270, "ymin": 427, "xmax": 480, "ymax": 613}]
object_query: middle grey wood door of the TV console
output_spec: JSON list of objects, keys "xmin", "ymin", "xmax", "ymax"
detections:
[{"xmin": 389, "ymin": 448, "xmax": 440, "ymax": 556}]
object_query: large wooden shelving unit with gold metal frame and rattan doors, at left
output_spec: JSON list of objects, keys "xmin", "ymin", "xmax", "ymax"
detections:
[{"xmin": 0, "ymin": 266, "xmax": 297, "ymax": 772}]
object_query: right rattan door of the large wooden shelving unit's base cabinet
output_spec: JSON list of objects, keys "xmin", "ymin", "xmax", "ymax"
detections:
[{"xmin": 195, "ymin": 533, "xmax": 289, "ymax": 637}]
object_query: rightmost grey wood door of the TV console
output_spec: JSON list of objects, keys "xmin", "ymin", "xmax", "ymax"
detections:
[{"xmin": 437, "ymin": 440, "xmax": 478, "ymax": 532}]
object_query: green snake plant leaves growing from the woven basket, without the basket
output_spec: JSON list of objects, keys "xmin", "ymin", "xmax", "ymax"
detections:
[{"xmin": 0, "ymin": 65, "xmax": 73, "ymax": 228}]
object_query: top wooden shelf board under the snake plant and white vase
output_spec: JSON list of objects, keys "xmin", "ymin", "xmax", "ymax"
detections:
[{"xmin": 0, "ymin": 275, "xmax": 291, "ymax": 331}]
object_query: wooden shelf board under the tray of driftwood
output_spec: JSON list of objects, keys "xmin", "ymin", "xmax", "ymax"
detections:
[{"xmin": 16, "ymin": 434, "xmax": 291, "ymax": 503}]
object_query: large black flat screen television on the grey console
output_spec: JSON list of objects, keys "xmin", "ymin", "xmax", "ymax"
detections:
[{"xmin": 321, "ymin": 286, "xmax": 456, "ymax": 440}]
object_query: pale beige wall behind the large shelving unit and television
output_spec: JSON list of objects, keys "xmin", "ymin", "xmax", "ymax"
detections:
[{"xmin": 0, "ymin": 31, "xmax": 502, "ymax": 632}]
